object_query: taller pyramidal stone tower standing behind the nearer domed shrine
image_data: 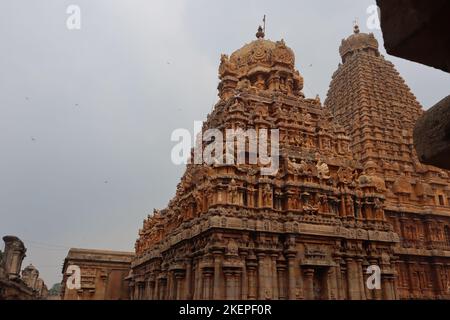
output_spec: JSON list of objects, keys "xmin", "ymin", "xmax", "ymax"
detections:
[{"xmin": 325, "ymin": 26, "xmax": 450, "ymax": 299}]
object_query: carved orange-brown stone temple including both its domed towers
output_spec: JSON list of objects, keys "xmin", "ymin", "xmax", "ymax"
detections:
[{"xmin": 128, "ymin": 26, "xmax": 450, "ymax": 300}]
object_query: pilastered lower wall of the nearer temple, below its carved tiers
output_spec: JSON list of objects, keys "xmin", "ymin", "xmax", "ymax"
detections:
[{"xmin": 130, "ymin": 230, "xmax": 395, "ymax": 300}]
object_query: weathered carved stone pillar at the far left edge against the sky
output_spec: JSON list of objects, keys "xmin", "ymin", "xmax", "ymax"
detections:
[{"xmin": 1, "ymin": 236, "xmax": 27, "ymax": 279}]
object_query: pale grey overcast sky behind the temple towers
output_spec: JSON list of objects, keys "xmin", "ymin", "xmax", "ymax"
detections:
[{"xmin": 0, "ymin": 0, "xmax": 450, "ymax": 287}]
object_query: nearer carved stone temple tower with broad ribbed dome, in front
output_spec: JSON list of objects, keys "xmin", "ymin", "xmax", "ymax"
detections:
[{"xmin": 129, "ymin": 28, "xmax": 404, "ymax": 300}]
